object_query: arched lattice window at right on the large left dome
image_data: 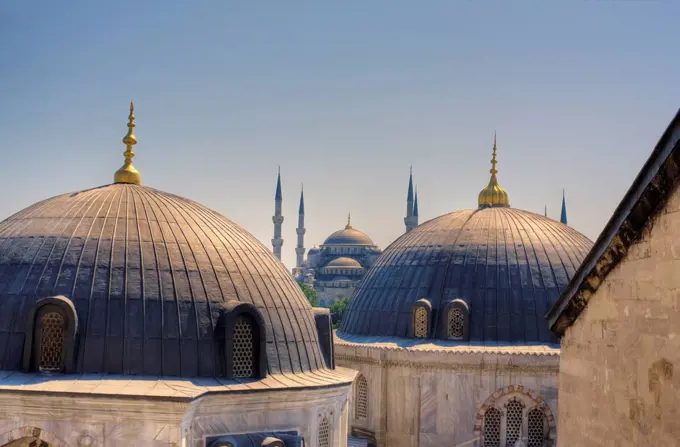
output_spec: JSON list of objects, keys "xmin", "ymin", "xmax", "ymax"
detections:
[{"xmin": 215, "ymin": 300, "xmax": 267, "ymax": 379}]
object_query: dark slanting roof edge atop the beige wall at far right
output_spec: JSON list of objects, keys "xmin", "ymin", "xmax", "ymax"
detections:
[{"xmin": 546, "ymin": 109, "xmax": 680, "ymax": 337}]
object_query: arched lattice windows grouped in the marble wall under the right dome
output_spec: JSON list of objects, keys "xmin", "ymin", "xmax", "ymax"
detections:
[{"xmin": 482, "ymin": 396, "xmax": 549, "ymax": 447}]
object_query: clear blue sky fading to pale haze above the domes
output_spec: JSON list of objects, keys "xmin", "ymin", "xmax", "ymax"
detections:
[{"xmin": 0, "ymin": 0, "xmax": 680, "ymax": 267}]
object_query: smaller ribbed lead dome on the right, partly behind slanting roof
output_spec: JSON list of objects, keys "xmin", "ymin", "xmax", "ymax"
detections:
[{"xmin": 339, "ymin": 207, "xmax": 592, "ymax": 343}]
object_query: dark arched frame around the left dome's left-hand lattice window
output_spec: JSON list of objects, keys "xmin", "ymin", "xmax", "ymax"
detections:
[{"xmin": 22, "ymin": 296, "xmax": 78, "ymax": 374}]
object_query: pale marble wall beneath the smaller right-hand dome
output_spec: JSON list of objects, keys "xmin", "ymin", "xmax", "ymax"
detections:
[{"xmin": 335, "ymin": 344, "xmax": 559, "ymax": 447}]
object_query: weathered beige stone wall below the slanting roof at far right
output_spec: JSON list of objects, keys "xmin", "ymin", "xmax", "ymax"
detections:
[{"xmin": 558, "ymin": 182, "xmax": 680, "ymax": 447}]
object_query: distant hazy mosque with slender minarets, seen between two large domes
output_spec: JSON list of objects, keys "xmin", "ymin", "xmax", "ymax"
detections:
[{"xmin": 272, "ymin": 143, "xmax": 567, "ymax": 307}]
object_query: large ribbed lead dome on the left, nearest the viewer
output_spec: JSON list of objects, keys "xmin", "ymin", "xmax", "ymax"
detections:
[{"xmin": 0, "ymin": 184, "xmax": 324, "ymax": 377}]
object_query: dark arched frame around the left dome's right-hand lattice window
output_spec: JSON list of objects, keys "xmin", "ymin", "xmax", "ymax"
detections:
[{"xmin": 215, "ymin": 300, "xmax": 267, "ymax": 379}]
